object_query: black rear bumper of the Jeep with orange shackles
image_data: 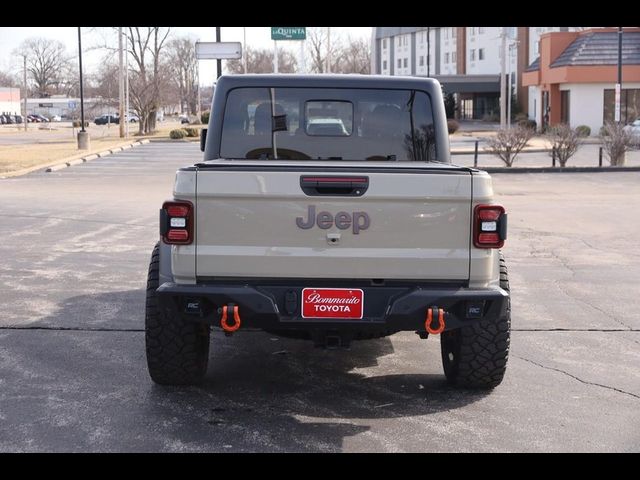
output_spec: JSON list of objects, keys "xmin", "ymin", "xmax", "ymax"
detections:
[{"xmin": 157, "ymin": 280, "xmax": 509, "ymax": 334}]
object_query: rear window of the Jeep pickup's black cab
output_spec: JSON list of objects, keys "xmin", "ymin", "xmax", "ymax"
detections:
[{"xmin": 220, "ymin": 87, "xmax": 436, "ymax": 162}]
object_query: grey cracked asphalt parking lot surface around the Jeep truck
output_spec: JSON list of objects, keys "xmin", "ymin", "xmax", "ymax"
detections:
[{"xmin": 0, "ymin": 143, "xmax": 640, "ymax": 452}]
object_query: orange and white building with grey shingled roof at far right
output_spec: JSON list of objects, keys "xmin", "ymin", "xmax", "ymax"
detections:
[{"xmin": 522, "ymin": 28, "xmax": 640, "ymax": 135}]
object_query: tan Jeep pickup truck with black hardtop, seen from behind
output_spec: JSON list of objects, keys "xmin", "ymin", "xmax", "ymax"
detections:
[{"xmin": 146, "ymin": 75, "xmax": 510, "ymax": 388}]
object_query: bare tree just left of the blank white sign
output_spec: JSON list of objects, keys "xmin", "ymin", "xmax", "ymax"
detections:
[{"xmin": 167, "ymin": 37, "xmax": 198, "ymax": 114}]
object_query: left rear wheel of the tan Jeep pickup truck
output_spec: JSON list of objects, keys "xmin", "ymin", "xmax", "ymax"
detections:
[{"xmin": 145, "ymin": 243, "xmax": 209, "ymax": 385}]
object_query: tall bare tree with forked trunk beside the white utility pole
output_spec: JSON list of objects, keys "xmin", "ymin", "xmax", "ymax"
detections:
[{"xmin": 126, "ymin": 27, "xmax": 170, "ymax": 135}]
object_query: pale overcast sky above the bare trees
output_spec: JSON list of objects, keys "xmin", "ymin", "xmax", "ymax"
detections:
[{"xmin": 0, "ymin": 27, "xmax": 371, "ymax": 85}]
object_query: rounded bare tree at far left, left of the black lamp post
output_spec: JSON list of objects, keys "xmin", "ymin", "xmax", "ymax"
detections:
[{"xmin": 14, "ymin": 37, "xmax": 73, "ymax": 98}]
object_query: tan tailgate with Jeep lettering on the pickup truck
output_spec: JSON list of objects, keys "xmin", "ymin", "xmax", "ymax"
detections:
[{"xmin": 195, "ymin": 162, "xmax": 472, "ymax": 281}]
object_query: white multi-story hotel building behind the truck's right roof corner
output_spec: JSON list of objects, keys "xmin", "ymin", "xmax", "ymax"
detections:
[{"xmin": 372, "ymin": 27, "xmax": 578, "ymax": 120}]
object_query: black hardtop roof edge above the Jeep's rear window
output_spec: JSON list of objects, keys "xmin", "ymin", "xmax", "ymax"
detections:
[{"xmin": 216, "ymin": 73, "xmax": 440, "ymax": 90}]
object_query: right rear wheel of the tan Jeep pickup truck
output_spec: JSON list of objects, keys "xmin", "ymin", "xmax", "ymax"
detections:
[{"xmin": 440, "ymin": 252, "xmax": 511, "ymax": 389}]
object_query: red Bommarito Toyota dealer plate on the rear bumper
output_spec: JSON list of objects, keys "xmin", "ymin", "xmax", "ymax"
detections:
[{"xmin": 302, "ymin": 288, "xmax": 364, "ymax": 319}]
